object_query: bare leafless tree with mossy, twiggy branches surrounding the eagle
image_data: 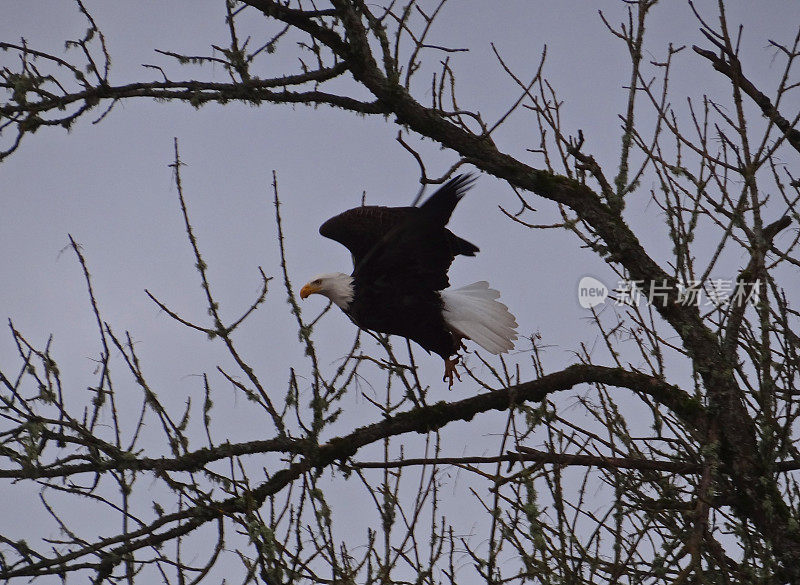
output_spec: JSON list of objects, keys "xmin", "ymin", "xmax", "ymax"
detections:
[{"xmin": 0, "ymin": 0, "xmax": 800, "ymax": 584}]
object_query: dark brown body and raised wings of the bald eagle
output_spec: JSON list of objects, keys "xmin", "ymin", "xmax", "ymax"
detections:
[{"xmin": 319, "ymin": 175, "xmax": 478, "ymax": 360}]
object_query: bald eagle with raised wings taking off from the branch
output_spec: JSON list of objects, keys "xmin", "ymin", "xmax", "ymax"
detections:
[{"xmin": 300, "ymin": 175, "xmax": 517, "ymax": 387}]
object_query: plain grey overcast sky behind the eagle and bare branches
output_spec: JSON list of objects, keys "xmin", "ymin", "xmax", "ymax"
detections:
[{"xmin": 0, "ymin": 0, "xmax": 800, "ymax": 580}]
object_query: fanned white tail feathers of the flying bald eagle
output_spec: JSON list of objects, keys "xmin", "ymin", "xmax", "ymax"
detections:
[{"xmin": 441, "ymin": 280, "xmax": 517, "ymax": 355}]
